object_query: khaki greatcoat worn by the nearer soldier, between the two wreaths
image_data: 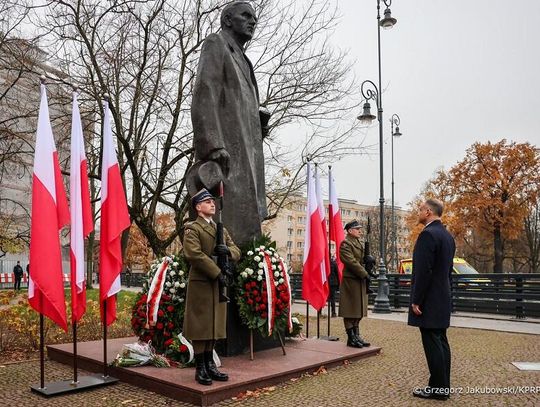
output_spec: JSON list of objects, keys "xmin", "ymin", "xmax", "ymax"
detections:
[{"xmin": 183, "ymin": 217, "xmax": 240, "ymax": 341}]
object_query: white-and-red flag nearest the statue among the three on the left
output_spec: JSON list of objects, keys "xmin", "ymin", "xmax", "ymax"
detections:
[{"xmin": 99, "ymin": 101, "xmax": 131, "ymax": 325}]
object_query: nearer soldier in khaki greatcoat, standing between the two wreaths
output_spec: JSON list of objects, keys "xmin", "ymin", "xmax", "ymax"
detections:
[{"xmin": 183, "ymin": 189, "xmax": 240, "ymax": 385}]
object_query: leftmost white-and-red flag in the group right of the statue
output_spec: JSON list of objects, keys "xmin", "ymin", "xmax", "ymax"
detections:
[{"xmin": 302, "ymin": 163, "xmax": 328, "ymax": 311}]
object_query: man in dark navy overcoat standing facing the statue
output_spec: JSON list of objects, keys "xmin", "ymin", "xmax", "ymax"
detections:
[{"xmin": 409, "ymin": 199, "xmax": 456, "ymax": 400}]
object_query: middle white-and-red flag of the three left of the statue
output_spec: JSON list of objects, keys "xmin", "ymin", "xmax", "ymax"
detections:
[{"xmin": 69, "ymin": 92, "xmax": 94, "ymax": 322}]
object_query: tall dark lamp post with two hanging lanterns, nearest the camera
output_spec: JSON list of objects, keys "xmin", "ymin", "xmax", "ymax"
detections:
[{"xmin": 358, "ymin": 0, "xmax": 397, "ymax": 313}]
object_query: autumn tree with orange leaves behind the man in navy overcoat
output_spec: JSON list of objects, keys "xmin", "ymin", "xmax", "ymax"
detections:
[{"xmin": 410, "ymin": 140, "xmax": 540, "ymax": 273}]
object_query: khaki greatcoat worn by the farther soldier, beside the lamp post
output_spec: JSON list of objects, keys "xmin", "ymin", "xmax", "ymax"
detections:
[{"xmin": 339, "ymin": 234, "xmax": 368, "ymax": 319}]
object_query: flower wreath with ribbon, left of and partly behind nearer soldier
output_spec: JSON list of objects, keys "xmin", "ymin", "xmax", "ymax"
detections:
[{"xmin": 131, "ymin": 256, "xmax": 188, "ymax": 353}]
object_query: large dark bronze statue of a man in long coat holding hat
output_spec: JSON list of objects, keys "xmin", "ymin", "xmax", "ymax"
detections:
[{"xmin": 188, "ymin": 1, "xmax": 269, "ymax": 245}]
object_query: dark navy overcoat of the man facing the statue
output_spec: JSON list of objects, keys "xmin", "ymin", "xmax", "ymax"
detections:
[{"xmin": 409, "ymin": 220, "xmax": 456, "ymax": 329}]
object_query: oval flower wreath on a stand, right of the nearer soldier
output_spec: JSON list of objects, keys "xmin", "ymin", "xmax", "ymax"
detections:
[{"xmin": 235, "ymin": 236, "xmax": 293, "ymax": 336}]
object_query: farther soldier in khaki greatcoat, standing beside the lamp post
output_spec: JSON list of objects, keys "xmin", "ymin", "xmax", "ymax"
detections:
[{"xmin": 339, "ymin": 220, "xmax": 370, "ymax": 348}]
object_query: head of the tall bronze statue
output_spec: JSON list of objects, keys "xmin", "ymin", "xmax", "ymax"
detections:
[{"xmin": 221, "ymin": 1, "xmax": 257, "ymax": 45}]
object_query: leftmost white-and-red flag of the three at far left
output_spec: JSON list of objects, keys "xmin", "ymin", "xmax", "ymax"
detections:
[{"xmin": 28, "ymin": 84, "xmax": 69, "ymax": 332}]
